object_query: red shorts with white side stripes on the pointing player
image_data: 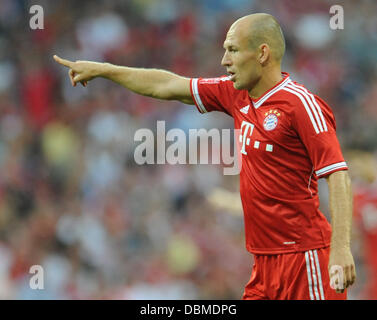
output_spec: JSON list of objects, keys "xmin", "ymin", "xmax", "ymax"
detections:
[{"xmin": 242, "ymin": 247, "xmax": 347, "ymax": 300}]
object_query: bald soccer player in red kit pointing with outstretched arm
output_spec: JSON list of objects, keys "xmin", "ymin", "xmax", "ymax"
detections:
[{"xmin": 54, "ymin": 13, "xmax": 356, "ymax": 300}]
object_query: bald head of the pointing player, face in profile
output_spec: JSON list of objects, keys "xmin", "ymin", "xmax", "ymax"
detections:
[{"xmin": 221, "ymin": 13, "xmax": 285, "ymax": 92}]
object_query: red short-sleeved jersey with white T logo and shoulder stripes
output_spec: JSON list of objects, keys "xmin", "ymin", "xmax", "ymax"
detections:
[{"xmin": 190, "ymin": 73, "xmax": 347, "ymax": 254}]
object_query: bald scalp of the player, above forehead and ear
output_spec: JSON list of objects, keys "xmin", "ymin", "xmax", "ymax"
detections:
[{"xmin": 229, "ymin": 13, "xmax": 285, "ymax": 62}]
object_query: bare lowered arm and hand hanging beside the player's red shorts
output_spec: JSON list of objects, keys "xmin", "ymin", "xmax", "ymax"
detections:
[{"xmin": 327, "ymin": 171, "xmax": 356, "ymax": 292}]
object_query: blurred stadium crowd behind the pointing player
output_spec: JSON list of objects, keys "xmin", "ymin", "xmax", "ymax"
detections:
[{"xmin": 0, "ymin": 0, "xmax": 377, "ymax": 299}]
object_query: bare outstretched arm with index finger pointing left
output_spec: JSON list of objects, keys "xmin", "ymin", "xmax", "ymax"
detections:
[{"xmin": 54, "ymin": 55, "xmax": 194, "ymax": 104}]
